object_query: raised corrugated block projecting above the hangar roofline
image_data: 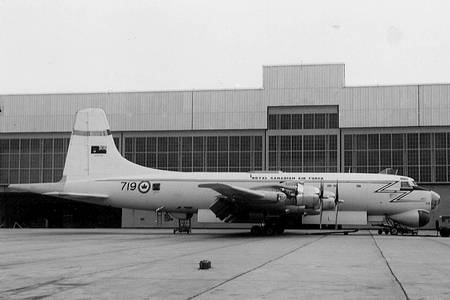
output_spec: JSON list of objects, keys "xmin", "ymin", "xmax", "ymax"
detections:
[{"xmin": 263, "ymin": 64, "xmax": 344, "ymax": 89}]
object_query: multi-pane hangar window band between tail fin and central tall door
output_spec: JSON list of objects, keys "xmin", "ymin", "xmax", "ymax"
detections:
[{"xmin": 125, "ymin": 135, "xmax": 263, "ymax": 172}]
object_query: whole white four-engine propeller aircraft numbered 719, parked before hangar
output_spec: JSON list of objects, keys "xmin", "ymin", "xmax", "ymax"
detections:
[{"xmin": 9, "ymin": 108, "xmax": 440, "ymax": 234}]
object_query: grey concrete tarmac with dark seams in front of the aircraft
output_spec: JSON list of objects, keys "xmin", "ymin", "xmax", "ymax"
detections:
[{"xmin": 0, "ymin": 229, "xmax": 450, "ymax": 299}]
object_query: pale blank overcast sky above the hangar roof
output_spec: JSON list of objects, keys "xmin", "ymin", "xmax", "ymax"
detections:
[{"xmin": 0, "ymin": 0, "xmax": 450, "ymax": 94}]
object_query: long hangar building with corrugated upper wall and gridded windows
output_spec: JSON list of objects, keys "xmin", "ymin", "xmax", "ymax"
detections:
[{"xmin": 0, "ymin": 64, "xmax": 450, "ymax": 227}]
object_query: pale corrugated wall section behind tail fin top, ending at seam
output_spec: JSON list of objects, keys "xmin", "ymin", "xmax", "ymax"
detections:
[{"xmin": 0, "ymin": 92, "xmax": 192, "ymax": 132}]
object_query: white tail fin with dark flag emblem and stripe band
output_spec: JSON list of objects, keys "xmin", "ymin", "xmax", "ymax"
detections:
[{"xmin": 63, "ymin": 108, "xmax": 142, "ymax": 180}]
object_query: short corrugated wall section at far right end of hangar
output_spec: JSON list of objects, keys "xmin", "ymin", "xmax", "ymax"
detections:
[{"xmin": 419, "ymin": 85, "xmax": 450, "ymax": 126}]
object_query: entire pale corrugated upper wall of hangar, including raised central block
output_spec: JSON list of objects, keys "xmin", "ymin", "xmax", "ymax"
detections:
[{"xmin": 0, "ymin": 65, "xmax": 450, "ymax": 132}]
